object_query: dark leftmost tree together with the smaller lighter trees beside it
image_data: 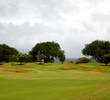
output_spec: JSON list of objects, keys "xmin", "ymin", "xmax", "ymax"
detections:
[{"xmin": 0, "ymin": 44, "xmax": 32, "ymax": 65}]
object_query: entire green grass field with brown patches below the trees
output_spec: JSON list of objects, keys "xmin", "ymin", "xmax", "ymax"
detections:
[{"xmin": 0, "ymin": 63, "xmax": 110, "ymax": 100}]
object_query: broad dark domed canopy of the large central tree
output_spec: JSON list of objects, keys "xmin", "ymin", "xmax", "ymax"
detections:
[{"xmin": 29, "ymin": 42, "xmax": 65, "ymax": 62}]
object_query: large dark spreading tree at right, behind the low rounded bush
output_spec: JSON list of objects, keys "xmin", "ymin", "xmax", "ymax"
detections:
[{"xmin": 82, "ymin": 40, "xmax": 110, "ymax": 63}]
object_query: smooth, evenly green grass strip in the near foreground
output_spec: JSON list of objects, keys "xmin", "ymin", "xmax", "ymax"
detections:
[{"xmin": 0, "ymin": 79, "xmax": 107, "ymax": 100}]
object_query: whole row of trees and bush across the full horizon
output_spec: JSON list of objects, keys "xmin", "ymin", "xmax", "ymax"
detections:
[{"xmin": 0, "ymin": 40, "xmax": 110, "ymax": 65}]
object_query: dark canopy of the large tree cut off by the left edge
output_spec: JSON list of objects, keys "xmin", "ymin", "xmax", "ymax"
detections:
[{"xmin": 0, "ymin": 44, "xmax": 18, "ymax": 62}]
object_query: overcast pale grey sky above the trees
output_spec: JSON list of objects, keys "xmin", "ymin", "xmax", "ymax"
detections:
[{"xmin": 0, "ymin": 0, "xmax": 110, "ymax": 58}]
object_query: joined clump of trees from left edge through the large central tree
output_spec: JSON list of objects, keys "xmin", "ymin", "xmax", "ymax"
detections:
[{"xmin": 0, "ymin": 41, "xmax": 65, "ymax": 65}]
